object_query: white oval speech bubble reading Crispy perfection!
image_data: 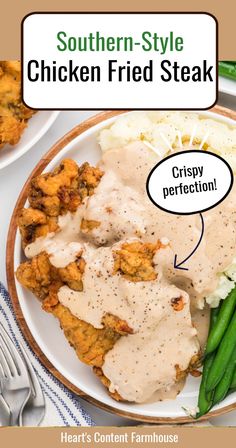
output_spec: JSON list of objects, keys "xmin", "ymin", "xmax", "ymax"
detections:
[{"xmin": 146, "ymin": 150, "xmax": 234, "ymax": 215}]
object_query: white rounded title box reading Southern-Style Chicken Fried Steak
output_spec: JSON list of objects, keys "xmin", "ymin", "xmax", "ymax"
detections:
[{"xmin": 22, "ymin": 13, "xmax": 217, "ymax": 110}]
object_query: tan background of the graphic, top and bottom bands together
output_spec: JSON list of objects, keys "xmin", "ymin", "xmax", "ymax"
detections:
[{"xmin": 0, "ymin": 0, "xmax": 236, "ymax": 440}]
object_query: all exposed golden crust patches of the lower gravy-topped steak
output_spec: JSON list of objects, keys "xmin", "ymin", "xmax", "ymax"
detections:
[{"xmin": 16, "ymin": 242, "xmax": 198, "ymax": 401}]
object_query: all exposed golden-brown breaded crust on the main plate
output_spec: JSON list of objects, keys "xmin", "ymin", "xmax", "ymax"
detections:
[{"xmin": 16, "ymin": 159, "xmax": 197, "ymax": 401}]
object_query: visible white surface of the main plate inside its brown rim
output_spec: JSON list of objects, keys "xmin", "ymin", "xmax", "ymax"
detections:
[{"xmin": 14, "ymin": 112, "xmax": 236, "ymax": 419}]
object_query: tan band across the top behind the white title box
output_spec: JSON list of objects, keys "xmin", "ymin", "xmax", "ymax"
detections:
[{"xmin": 0, "ymin": 0, "xmax": 236, "ymax": 60}]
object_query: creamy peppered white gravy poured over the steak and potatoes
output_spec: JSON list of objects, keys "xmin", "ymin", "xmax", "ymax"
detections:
[{"xmin": 25, "ymin": 142, "xmax": 236, "ymax": 402}]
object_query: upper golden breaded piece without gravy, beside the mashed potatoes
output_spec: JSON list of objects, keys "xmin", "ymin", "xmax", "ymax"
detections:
[{"xmin": 18, "ymin": 159, "xmax": 103, "ymax": 247}]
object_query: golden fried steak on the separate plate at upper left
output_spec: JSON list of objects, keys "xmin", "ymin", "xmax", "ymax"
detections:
[{"xmin": 0, "ymin": 61, "xmax": 35, "ymax": 148}]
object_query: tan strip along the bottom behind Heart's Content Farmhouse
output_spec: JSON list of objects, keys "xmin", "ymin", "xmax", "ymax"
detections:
[{"xmin": 0, "ymin": 426, "xmax": 235, "ymax": 448}]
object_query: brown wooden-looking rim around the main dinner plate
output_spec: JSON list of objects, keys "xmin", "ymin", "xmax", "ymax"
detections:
[{"xmin": 6, "ymin": 106, "xmax": 236, "ymax": 424}]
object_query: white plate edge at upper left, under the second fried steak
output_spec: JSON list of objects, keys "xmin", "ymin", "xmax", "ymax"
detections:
[{"xmin": 0, "ymin": 111, "xmax": 59, "ymax": 170}]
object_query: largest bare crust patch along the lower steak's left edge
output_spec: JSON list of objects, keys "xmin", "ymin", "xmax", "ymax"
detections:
[{"xmin": 16, "ymin": 252, "xmax": 123, "ymax": 366}]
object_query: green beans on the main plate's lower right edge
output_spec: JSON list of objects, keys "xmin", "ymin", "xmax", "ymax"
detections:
[{"xmin": 196, "ymin": 288, "xmax": 236, "ymax": 418}]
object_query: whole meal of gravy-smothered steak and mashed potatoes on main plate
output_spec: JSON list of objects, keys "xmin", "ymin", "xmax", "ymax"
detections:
[{"xmin": 16, "ymin": 112, "xmax": 236, "ymax": 412}]
